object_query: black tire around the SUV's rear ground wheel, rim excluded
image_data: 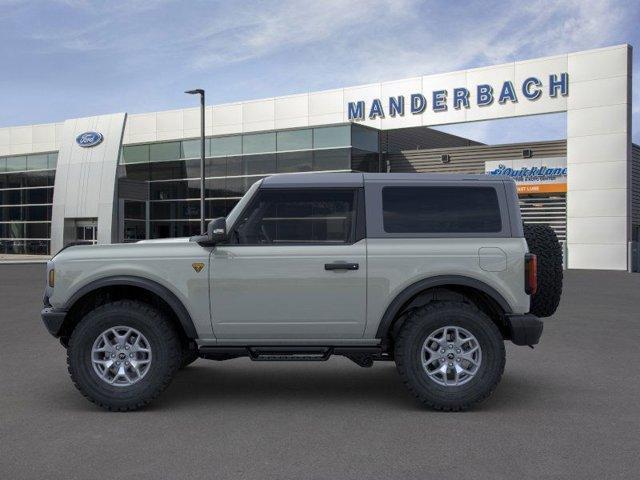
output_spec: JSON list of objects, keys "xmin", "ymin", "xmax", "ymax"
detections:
[{"xmin": 395, "ymin": 301, "xmax": 505, "ymax": 411}]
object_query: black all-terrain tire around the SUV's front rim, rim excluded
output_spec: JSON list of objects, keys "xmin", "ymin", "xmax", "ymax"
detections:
[{"xmin": 67, "ymin": 300, "xmax": 182, "ymax": 412}]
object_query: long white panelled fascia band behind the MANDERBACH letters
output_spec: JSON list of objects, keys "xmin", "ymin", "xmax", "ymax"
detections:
[{"xmin": 116, "ymin": 45, "xmax": 630, "ymax": 143}]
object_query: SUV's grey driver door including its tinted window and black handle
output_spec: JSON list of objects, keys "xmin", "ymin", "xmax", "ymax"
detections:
[{"xmin": 210, "ymin": 188, "xmax": 367, "ymax": 340}]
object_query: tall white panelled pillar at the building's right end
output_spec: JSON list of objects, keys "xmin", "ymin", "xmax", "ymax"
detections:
[{"xmin": 567, "ymin": 45, "xmax": 632, "ymax": 270}]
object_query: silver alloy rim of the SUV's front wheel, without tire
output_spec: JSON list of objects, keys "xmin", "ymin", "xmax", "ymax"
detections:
[{"xmin": 91, "ymin": 326, "xmax": 151, "ymax": 387}]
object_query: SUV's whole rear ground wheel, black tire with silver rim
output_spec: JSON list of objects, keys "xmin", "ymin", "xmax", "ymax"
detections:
[{"xmin": 395, "ymin": 302, "xmax": 505, "ymax": 411}]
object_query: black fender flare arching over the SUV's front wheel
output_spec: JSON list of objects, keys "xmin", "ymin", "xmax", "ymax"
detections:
[{"xmin": 62, "ymin": 275, "xmax": 198, "ymax": 339}]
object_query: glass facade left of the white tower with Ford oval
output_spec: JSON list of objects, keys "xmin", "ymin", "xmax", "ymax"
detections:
[{"xmin": 0, "ymin": 152, "xmax": 58, "ymax": 255}]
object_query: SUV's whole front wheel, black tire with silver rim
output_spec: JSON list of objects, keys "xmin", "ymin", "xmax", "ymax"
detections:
[{"xmin": 67, "ymin": 300, "xmax": 182, "ymax": 411}]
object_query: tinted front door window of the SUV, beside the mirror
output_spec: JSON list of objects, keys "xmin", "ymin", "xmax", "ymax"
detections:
[{"xmin": 233, "ymin": 189, "xmax": 356, "ymax": 245}]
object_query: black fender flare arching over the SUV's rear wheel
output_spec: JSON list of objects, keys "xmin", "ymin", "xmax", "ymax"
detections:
[{"xmin": 376, "ymin": 275, "xmax": 511, "ymax": 339}]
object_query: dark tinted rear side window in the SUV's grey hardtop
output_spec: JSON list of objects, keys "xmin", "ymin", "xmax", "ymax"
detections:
[{"xmin": 382, "ymin": 186, "xmax": 502, "ymax": 234}]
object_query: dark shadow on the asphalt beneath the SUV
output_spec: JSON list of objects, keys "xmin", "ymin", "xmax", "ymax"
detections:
[{"xmin": 46, "ymin": 359, "xmax": 552, "ymax": 415}]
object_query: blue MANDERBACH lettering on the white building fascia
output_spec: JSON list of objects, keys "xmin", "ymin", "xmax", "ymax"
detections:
[{"xmin": 347, "ymin": 73, "xmax": 569, "ymax": 121}]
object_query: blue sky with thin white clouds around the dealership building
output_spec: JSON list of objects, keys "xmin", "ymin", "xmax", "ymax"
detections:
[{"xmin": 0, "ymin": 0, "xmax": 640, "ymax": 143}]
